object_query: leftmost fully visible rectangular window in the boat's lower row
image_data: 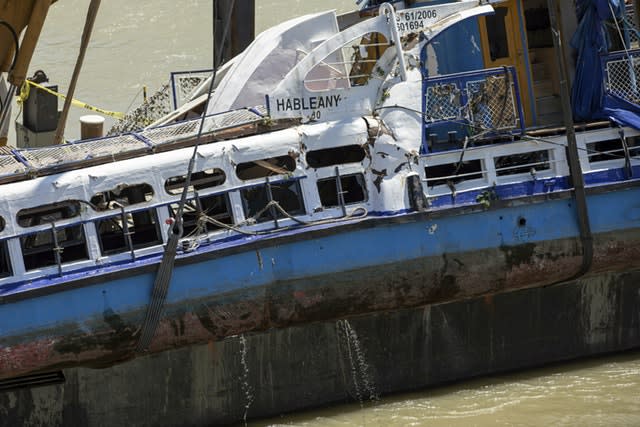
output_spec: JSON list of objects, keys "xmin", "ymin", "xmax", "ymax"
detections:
[{"xmin": 20, "ymin": 224, "xmax": 89, "ymax": 271}]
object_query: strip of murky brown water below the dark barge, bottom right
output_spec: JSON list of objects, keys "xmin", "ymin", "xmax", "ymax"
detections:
[{"xmin": 248, "ymin": 352, "xmax": 640, "ymax": 427}]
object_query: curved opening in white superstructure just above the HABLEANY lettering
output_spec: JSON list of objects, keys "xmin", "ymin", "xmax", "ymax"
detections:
[{"xmin": 304, "ymin": 33, "xmax": 389, "ymax": 91}]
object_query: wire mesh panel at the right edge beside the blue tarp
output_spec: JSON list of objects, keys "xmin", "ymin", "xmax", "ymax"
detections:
[{"xmin": 604, "ymin": 50, "xmax": 640, "ymax": 104}]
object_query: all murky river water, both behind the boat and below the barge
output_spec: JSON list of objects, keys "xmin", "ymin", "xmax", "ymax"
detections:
[{"xmin": 22, "ymin": 0, "xmax": 640, "ymax": 426}]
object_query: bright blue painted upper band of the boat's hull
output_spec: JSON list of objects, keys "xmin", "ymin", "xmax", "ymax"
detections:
[{"xmin": 0, "ymin": 174, "xmax": 640, "ymax": 340}]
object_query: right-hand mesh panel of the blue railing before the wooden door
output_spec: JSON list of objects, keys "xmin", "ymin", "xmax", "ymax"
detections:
[{"xmin": 467, "ymin": 75, "xmax": 520, "ymax": 131}]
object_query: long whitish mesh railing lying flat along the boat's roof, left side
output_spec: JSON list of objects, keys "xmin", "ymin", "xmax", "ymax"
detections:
[{"xmin": 0, "ymin": 107, "xmax": 266, "ymax": 183}]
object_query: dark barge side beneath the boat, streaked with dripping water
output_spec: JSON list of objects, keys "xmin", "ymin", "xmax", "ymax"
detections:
[{"xmin": 0, "ymin": 270, "xmax": 640, "ymax": 426}]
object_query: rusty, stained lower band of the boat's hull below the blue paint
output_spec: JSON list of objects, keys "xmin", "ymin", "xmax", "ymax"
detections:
[{"xmin": 0, "ymin": 224, "xmax": 640, "ymax": 379}]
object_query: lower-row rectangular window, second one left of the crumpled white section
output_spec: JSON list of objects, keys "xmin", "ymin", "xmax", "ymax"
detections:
[{"xmin": 240, "ymin": 180, "xmax": 305, "ymax": 222}]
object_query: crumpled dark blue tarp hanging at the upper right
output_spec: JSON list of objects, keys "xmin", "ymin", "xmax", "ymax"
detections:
[{"xmin": 571, "ymin": 0, "xmax": 640, "ymax": 129}]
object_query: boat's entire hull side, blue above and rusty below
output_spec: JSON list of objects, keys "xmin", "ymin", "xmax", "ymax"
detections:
[{"xmin": 0, "ymin": 182, "xmax": 640, "ymax": 377}]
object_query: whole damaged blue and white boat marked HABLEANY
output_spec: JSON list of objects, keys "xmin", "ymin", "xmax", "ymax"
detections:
[{"xmin": 0, "ymin": 0, "xmax": 640, "ymax": 408}]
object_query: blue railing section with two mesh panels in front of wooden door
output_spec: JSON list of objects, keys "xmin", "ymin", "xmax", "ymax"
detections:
[{"xmin": 423, "ymin": 67, "xmax": 524, "ymax": 153}]
